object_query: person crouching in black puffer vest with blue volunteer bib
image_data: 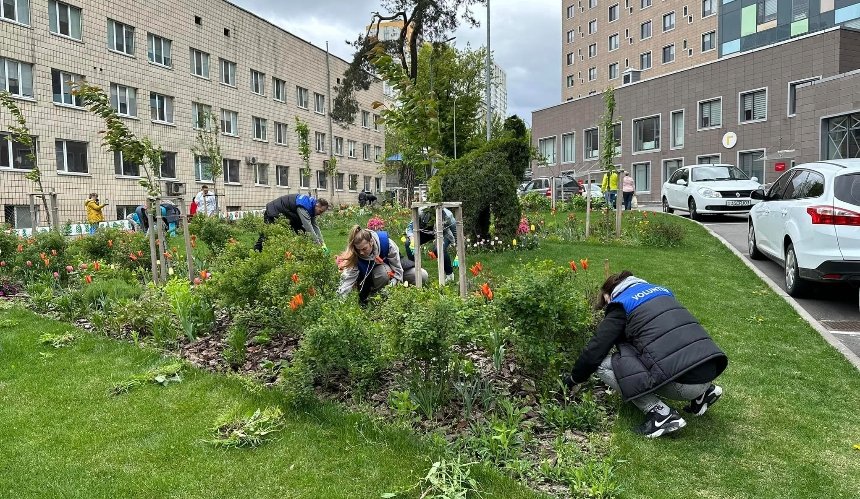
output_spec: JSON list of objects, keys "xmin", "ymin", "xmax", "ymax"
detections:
[{"xmin": 564, "ymin": 270, "xmax": 728, "ymax": 438}]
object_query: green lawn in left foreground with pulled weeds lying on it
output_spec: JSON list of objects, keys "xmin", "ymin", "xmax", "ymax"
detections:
[{"xmin": 0, "ymin": 309, "xmax": 534, "ymax": 498}]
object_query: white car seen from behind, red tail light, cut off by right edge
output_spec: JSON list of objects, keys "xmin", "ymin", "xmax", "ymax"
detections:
[{"xmin": 748, "ymin": 159, "xmax": 860, "ymax": 296}]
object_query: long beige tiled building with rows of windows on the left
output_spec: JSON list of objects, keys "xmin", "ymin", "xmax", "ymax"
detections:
[{"xmin": 0, "ymin": 0, "xmax": 385, "ymax": 227}]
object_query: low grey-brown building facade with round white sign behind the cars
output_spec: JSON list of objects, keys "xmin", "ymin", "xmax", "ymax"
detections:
[{"xmin": 532, "ymin": 27, "xmax": 860, "ymax": 202}]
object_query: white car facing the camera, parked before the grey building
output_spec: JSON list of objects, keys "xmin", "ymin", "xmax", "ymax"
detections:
[{"xmin": 660, "ymin": 165, "xmax": 761, "ymax": 220}]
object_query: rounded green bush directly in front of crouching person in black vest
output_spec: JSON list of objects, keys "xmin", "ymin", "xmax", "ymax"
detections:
[{"xmin": 496, "ymin": 260, "xmax": 593, "ymax": 377}]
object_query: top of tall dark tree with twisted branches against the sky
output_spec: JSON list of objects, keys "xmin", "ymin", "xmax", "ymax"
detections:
[{"xmin": 331, "ymin": 0, "xmax": 485, "ymax": 124}]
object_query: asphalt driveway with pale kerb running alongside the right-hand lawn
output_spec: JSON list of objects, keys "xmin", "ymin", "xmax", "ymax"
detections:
[{"xmin": 639, "ymin": 201, "xmax": 860, "ymax": 369}]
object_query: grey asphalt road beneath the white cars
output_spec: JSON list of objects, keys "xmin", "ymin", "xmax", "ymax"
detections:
[{"xmin": 640, "ymin": 205, "xmax": 860, "ymax": 362}]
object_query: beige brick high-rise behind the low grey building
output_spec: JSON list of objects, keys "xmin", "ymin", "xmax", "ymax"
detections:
[{"xmin": 561, "ymin": 0, "xmax": 719, "ymax": 101}]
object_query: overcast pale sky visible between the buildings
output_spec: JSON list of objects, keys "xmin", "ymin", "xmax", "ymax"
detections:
[{"xmin": 230, "ymin": 0, "xmax": 561, "ymax": 123}]
